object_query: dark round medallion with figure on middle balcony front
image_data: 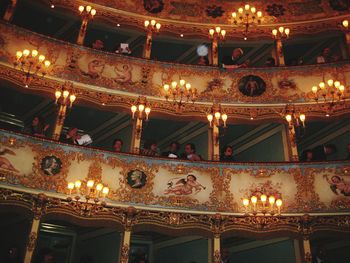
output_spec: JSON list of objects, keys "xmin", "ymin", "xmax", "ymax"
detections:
[{"xmin": 238, "ymin": 75, "xmax": 266, "ymax": 97}]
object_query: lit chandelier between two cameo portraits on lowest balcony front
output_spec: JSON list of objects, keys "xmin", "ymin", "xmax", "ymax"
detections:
[{"xmin": 67, "ymin": 180, "xmax": 109, "ymax": 215}]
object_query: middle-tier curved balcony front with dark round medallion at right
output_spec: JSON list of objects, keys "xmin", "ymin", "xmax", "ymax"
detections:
[{"xmin": 0, "ymin": 23, "xmax": 350, "ymax": 118}]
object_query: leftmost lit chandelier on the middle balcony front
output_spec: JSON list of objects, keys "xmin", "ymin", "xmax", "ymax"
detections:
[{"xmin": 13, "ymin": 49, "xmax": 51, "ymax": 88}]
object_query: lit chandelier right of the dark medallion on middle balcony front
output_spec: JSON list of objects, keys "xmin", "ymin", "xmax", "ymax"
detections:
[{"xmin": 311, "ymin": 79, "xmax": 345, "ymax": 103}]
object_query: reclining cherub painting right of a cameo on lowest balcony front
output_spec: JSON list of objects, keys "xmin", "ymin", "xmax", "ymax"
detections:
[{"xmin": 164, "ymin": 174, "xmax": 206, "ymax": 195}]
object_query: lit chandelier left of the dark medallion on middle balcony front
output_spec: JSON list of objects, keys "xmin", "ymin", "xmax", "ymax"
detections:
[{"xmin": 163, "ymin": 79, "xmax": 197, "ymax": 106}]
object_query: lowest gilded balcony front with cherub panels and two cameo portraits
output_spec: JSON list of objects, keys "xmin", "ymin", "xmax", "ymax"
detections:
[{"xmin": 0, "ymin": 130, "xmax": 350, "ymax": 216}]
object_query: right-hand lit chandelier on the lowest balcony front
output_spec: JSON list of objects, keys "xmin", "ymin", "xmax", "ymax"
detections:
[{"xmin": 242, "ymin": 194, "xmax": 283, "ymax": 215}]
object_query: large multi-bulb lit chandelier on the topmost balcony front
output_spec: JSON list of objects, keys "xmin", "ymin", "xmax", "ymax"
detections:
[{"xmin": 231, "ymin": 4, "xmax": 262, "ymax": 40}]
